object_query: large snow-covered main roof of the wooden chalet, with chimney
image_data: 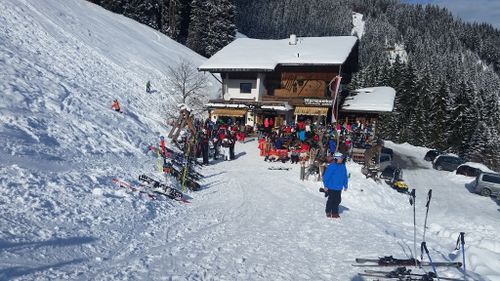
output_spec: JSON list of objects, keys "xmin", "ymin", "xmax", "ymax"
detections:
[{"xmin": 198, "ymin": 36, "xmax": 358, "ymax": 71}]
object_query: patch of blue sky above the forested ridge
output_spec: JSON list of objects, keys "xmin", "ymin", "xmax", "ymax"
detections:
[{"xmin": 402, "ymin": 0, "xmax": 500, "ymax": 29}]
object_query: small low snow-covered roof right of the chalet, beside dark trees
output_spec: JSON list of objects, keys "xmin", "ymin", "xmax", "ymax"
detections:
[{"xmin": 342, "ymin": 87, "xmax": 396, "ymax": 112}]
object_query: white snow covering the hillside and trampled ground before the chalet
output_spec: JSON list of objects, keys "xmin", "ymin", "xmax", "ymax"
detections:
[{"xmin": 0, "ymin": 0, "xmax": 500, "ymax": 280}]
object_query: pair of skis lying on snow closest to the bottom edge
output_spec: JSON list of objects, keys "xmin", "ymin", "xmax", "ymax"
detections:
[{"xmin": 359, "ymin": 267, "xmax": 462, "ymax": 281}]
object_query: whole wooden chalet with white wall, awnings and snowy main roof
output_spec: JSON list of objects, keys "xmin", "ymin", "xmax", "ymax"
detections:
[{"xmin": 198, "ymin": 35, "xmax": 358, "ymax": 126}]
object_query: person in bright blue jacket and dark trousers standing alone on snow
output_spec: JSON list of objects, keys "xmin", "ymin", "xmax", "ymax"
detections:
[{"xmin": 323, "ymin": 152, "xmax": 348, "ymax": 218}]
